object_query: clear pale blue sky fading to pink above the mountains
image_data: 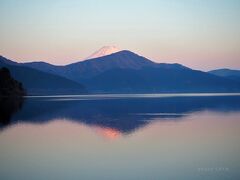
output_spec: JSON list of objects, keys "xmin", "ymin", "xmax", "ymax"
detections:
[{"xmin": 0, "ymin": 0, "xmax": 240, "ymax": 70}]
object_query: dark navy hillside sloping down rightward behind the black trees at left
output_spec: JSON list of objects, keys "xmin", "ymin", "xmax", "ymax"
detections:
[{"xmin": 0, "ymin": 56, "xmax": 86, "ymax": 95}]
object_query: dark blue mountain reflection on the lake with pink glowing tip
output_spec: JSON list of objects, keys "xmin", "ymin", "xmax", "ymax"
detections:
[{"xmin": 1, "ymin": 95, "xmax": 240, "ymax": 134}]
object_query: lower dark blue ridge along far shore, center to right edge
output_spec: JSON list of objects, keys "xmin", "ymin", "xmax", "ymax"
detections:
[{"xmin": 82, "ymin": 67, "xmax": 240, "ymax": 93}]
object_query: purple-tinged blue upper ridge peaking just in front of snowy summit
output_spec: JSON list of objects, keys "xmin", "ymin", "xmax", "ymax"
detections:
[{"xmin": 22, "ymin": 50, "xmax": 187, "ymax": 82}]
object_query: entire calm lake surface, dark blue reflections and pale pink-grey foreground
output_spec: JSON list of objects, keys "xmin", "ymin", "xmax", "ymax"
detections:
[{"xmin": 0, "ymin": 94, "xmax": 240, "ymax": 180}]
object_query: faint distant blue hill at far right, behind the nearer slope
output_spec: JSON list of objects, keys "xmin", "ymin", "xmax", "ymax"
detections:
[{"xmin": 208, "ymin": 69, "xmax": 240, "ymax": 82}]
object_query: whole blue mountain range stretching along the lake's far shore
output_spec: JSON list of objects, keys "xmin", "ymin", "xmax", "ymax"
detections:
[{"xmin": 0, "ymin": 47, "xmax": 240, "ymax": 94}]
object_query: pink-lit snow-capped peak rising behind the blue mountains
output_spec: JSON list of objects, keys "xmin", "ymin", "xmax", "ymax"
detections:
[{"xmin": 86, "ymin": 46, "xmax": 121, "ymax": 59}]
